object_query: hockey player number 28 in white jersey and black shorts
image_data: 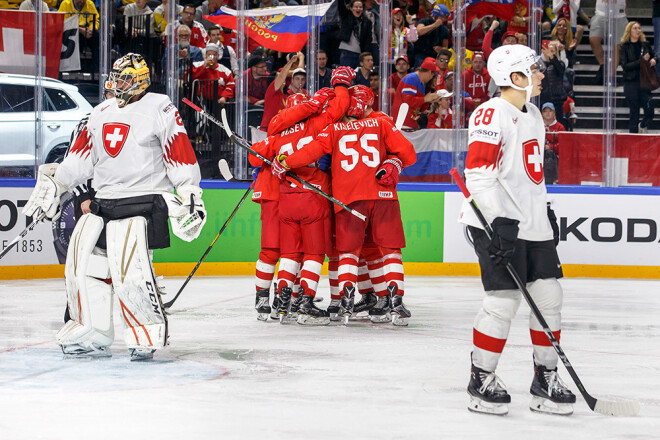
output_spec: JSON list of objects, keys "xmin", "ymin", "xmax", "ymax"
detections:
[{"xmin": 460, "ymin": 45, "xmax": 575, "ymax": 415}]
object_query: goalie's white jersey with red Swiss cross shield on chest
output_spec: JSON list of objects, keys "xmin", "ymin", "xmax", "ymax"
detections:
[{"xmin": 55, "ymin": 93, "xmax": 201, "ymax": 199}]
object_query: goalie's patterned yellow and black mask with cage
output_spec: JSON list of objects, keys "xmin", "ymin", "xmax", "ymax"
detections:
[{"xmin": 108, "ymin": 53, "xmax": 151, "ymax": 107}]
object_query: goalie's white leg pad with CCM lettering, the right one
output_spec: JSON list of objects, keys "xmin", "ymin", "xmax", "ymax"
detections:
[{"xmin": 106, "ymin": 217, "xmax": 168, "ymax": 349}]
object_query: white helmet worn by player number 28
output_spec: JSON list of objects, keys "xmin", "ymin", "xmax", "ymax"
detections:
[{"xmin": 488, "ymin": 44, "xmax": 543, "ymax": 101}]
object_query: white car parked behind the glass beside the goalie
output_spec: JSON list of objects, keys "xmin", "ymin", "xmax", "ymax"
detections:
[{"xmin": 0, "ymin": 73, "xmax": 92, "ymax": 167}]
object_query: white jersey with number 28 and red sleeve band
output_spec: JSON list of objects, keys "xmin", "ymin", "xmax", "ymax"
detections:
[{"xmin": 459, "ymin": 98, "xmax": 553, "ymax": 241}]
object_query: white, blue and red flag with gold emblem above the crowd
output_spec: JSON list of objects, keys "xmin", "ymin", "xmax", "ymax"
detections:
[{"xmin": 204, "ymin": 2, "xmax": 332, "ymax": 52}]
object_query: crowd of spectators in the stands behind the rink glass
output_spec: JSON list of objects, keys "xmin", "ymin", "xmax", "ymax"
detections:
[{"xmin": 0, "ymin": 0, "xmax": 660, "ymax": 181}]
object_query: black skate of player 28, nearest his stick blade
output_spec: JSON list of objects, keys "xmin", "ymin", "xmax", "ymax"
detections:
[{"xmin": 529, "ymin": 364, "xmax": 575, "ymax": 416}]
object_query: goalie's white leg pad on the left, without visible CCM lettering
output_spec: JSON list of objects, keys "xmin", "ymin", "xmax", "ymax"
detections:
[{"xmin": 57, "ymin": 214, "xmax": 114, "ymax": 356}]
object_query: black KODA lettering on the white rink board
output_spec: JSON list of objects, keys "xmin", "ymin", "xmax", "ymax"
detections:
[{"xmin": 559, "ymin": 217, "xmax": 660, "ymax": 243}]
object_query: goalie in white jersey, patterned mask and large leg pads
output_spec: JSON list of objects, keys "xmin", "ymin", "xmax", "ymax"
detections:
[{"xmin": 23, "ymin": 53, "xmax": 206, "ymax": 360}]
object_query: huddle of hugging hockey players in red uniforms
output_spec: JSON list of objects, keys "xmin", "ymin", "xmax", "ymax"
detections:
[{"xmin": 250, "ymin": 67, "xmax": 416, "ymax": 325}]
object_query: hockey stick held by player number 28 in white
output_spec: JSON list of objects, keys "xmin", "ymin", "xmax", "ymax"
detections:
[{"xmin": 449, "ymin": 168, "xmax": 639, "ymax": 416}]
